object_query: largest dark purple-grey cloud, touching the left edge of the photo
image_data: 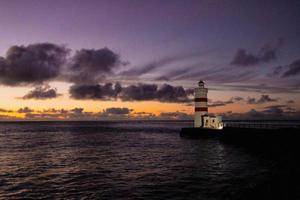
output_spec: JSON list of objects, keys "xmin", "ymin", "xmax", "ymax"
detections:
[{"xmin": 0, "ymin": 43, "xmax": 69, "ymax": 86}]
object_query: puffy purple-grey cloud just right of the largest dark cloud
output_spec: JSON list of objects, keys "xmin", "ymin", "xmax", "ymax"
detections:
[{"xmin": 67, "ymin": 48, "xmax": 122, "ymax": 83}]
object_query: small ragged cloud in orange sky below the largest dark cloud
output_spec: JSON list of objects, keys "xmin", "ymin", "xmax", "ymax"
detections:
[{"xmin": 21, "ymin": 85, "xmax": 62, "ymax": 100}]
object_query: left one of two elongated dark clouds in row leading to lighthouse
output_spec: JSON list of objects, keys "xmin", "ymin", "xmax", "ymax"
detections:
[{"xmin": 69, "ymin": 83, "xmax": 122, "ymax": 100}]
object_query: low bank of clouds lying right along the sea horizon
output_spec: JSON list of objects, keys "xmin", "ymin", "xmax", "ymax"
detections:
[{"xmin": 0, "ymin": 105, "xmax": 300, "ymax": 120}]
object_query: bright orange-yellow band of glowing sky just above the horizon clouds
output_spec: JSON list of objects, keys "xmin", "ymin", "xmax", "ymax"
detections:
[{"xmin": 0, "ymin": 82, "xmax": 300, "ymax": 119}]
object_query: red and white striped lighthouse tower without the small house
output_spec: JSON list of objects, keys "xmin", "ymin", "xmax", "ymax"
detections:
[{"xmin": 194, "ymin": 81, "xmax": 208, "ymax": 127}]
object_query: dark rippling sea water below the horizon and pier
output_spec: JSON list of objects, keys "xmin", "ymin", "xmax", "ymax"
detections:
[{"xmin": 0, "ymin": 122, "xmax": 300, "ymax": 200}]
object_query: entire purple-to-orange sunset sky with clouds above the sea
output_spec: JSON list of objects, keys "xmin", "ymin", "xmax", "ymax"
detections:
[{"xmin": 0, "ymin": 0, "xmax": 300, "ymax": 120}]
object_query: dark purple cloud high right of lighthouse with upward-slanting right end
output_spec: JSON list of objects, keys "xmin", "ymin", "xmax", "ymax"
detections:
[{"xmin": 230, "ymin": 39, "xmax": 283, "ymax": 66}]
